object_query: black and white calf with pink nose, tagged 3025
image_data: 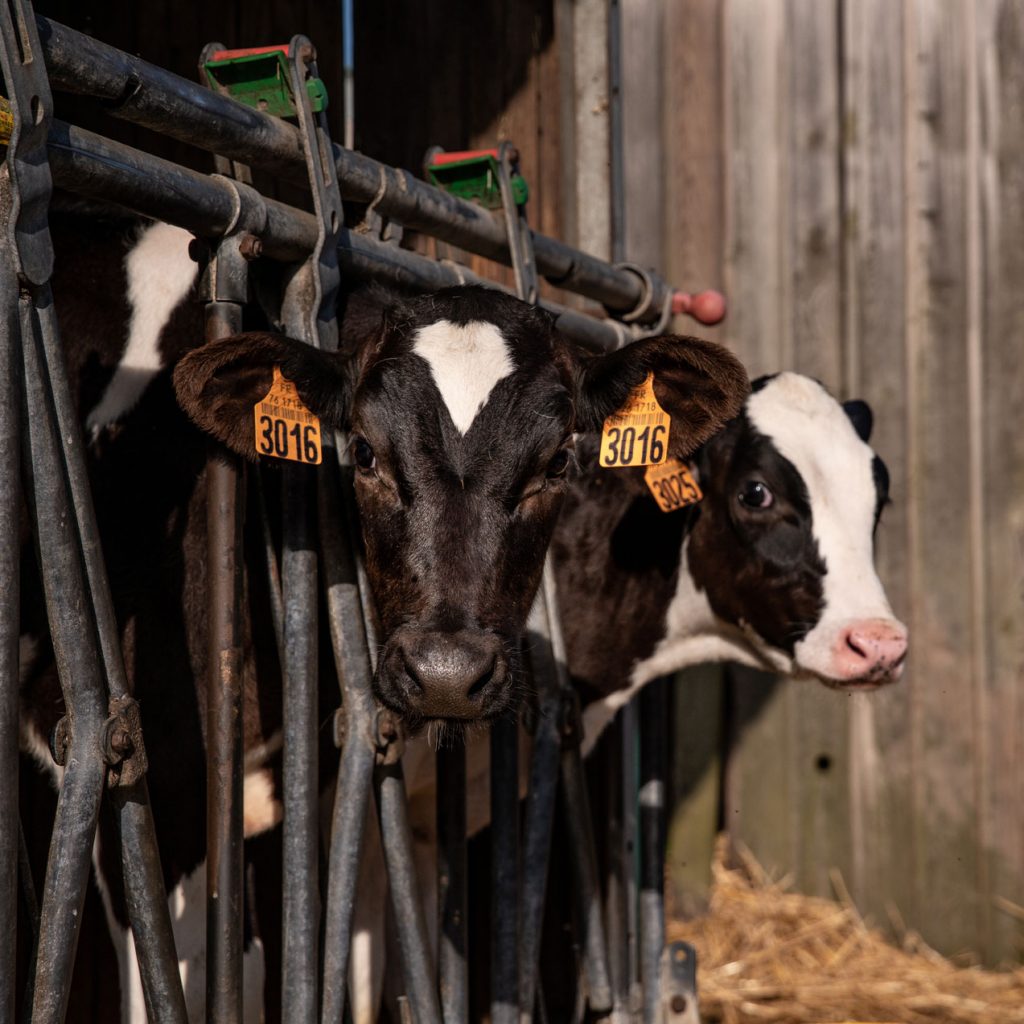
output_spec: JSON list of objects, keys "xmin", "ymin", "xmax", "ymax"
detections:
[{"xmin": 352, "ymin": 373, "xmax": 907, "ymax": 1024}]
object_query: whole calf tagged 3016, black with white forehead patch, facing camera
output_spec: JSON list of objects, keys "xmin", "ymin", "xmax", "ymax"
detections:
[{"xmin": 23, "ymin": 211, "xmax": 748, "ymax": 1019}]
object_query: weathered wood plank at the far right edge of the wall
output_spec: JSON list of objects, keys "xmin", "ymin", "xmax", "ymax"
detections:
[{"xmin": 977, "ymin": 0, "xmax": 1024, "ymax": 962}]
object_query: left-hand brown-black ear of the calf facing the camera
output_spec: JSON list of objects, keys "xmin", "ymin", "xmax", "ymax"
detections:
[{"xmin": 174, "ymin": 332, "xmax": 353, "ymax": 461}]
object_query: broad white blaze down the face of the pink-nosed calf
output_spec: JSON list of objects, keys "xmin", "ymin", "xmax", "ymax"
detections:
[{"xmin": 746, "ymin": 373, "xmax": 902, "ymax": 677}]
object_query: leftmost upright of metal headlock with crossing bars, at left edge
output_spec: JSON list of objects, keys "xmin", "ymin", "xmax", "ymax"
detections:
[{"xmin": 0, "ymin": 0, "xmax": 186, "ymax": 1024}]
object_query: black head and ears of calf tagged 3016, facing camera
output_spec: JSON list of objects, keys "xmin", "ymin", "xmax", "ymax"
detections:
[{"xmin": 175, "ymin": 287, "xmax": 748, "ymax": 725}]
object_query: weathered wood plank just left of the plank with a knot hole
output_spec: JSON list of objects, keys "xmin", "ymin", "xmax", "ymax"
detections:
[{"xmin": 723, "ymin": 0, "xmax": 799, "ymax": 870}]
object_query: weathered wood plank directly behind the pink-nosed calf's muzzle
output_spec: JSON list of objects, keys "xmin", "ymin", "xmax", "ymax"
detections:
[{"xmin": 842, "ymin": 0, "xmax": 918, "ymax": 923}]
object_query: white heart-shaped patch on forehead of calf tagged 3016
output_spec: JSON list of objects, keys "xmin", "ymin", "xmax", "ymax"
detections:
[{"xmin": 413, "ymin": 319, "xmax": 515, "ymax": 434}]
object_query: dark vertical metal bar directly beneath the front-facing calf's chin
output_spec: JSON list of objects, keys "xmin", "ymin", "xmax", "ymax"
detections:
[{"xmin": 437, "ymin": 739, "xmax": 469, "ymax": 1024}]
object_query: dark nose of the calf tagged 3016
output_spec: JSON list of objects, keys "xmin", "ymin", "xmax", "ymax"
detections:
[{"xmin": 401, "ymin": 630, "xmax": 508, "ymax": 718}]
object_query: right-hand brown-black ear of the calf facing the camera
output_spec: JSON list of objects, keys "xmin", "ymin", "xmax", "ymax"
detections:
[{"xmin": 577, "ymin": 335, "xmax": 751, "ymax": 459}]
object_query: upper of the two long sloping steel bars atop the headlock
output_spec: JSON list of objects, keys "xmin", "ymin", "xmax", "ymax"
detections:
[{"xmin": 38, "ymin": 17, "xmax": 672, "ymax": 323}]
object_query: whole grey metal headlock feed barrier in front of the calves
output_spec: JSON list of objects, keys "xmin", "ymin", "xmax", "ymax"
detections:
[{"xmin": 0, "ymin": 8, "xmax": 710, "ymax": 1024}]
